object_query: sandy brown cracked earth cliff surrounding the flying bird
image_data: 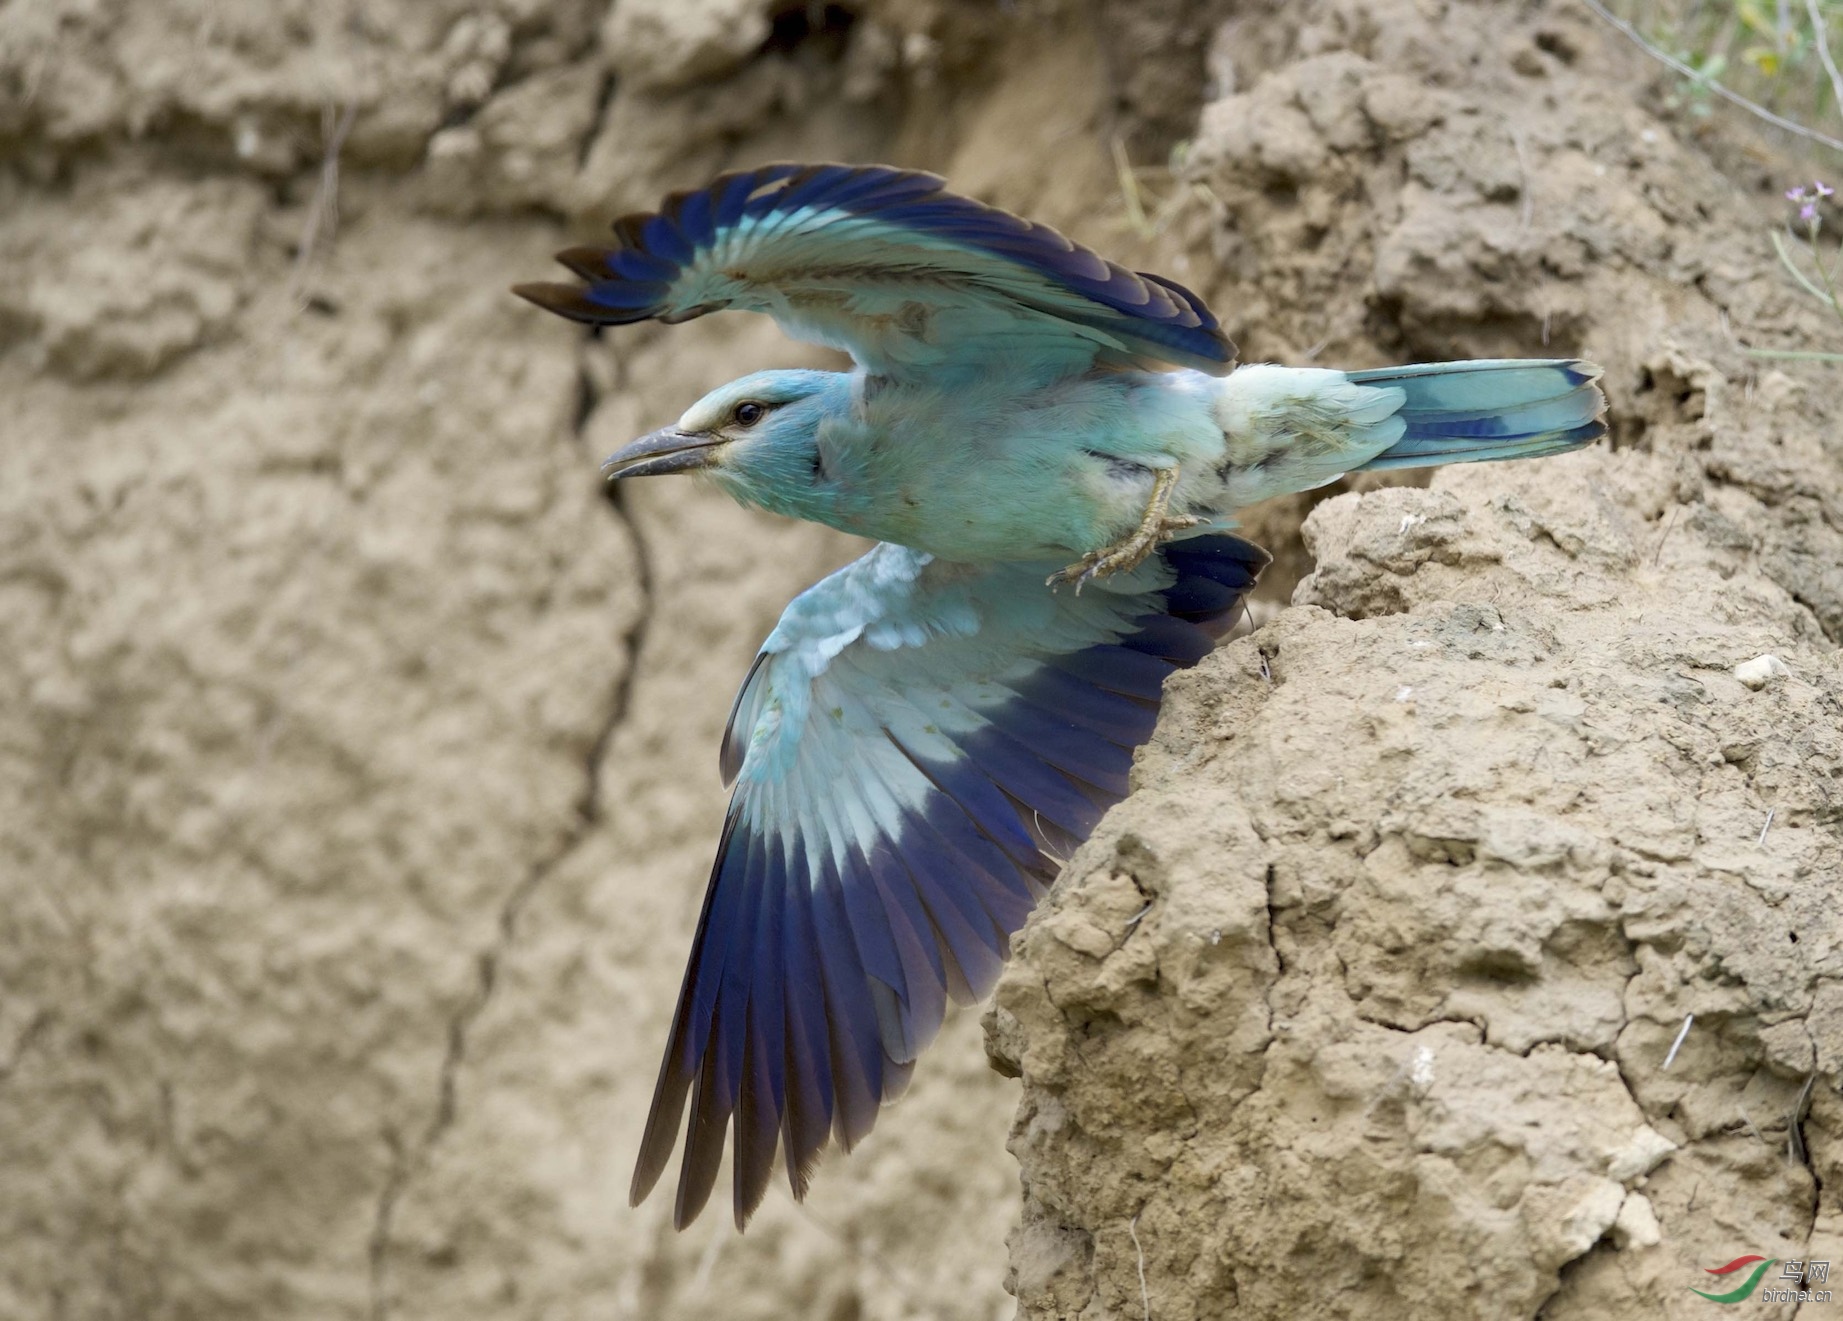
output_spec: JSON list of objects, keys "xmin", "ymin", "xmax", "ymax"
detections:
[{"xmin": 0, "ymin": 0, "xmax": 1843, "ymax": 1321}]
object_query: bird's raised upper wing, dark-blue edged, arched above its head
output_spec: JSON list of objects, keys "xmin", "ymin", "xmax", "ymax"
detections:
[{"xmin": 514, "ymin": 164, "xmax": 1235, "ymax": 376}]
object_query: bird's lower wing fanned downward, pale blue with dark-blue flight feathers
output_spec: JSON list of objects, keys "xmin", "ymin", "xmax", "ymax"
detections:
[{"xmin": 632, "ymin": 534, "xmax": 1268, "ymax": 1227}]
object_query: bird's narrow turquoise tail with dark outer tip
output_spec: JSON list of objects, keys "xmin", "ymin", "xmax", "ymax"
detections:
[{"xmin": 1349, "ymin": 357, "xmax": 1607, "ymax": 472}]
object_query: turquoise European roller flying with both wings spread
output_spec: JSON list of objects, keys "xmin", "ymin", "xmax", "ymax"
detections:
[{"xmin": 518, "ymin": 164, "xmax": 1603, "ymax": 1227}]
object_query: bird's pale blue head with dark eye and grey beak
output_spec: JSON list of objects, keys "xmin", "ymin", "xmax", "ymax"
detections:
[{"xmin": 601, "ymin": 370, "xmax": 851, "ymax": 518}]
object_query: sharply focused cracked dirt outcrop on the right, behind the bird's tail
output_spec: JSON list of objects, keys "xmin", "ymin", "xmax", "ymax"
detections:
[{"xmin": 988, "ymin": 4, "xmax": 1843, "ymax": 1321}]
